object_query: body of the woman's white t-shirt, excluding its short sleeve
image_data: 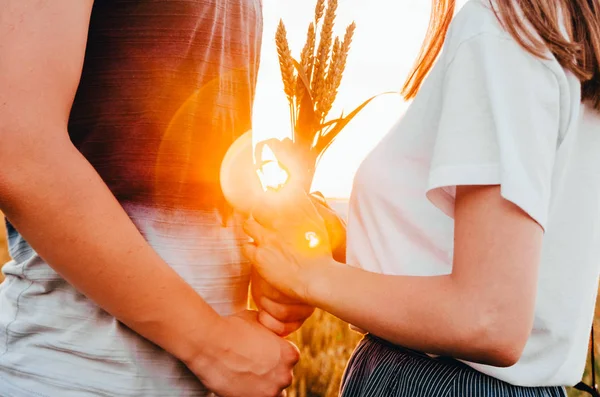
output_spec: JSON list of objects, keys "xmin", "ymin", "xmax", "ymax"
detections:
[{"xmin": 348, "ymin": 0, "xmax": 600, "ymax": 386}]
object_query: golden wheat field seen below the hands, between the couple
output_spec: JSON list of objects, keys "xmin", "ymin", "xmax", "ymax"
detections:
[{"xmin": 0, "ymin": 213, "xmax": 600, "ymax": 397}]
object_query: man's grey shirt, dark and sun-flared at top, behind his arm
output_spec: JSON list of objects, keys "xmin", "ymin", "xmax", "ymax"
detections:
[{"xmin": 0, "ymin": 0, "xmax": 262, "ymax": 397}]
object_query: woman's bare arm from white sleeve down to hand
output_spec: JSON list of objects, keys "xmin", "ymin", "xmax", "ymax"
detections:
[{"xmin": 246, "ymin": 186, "xmax": 543, "ymax": 366}]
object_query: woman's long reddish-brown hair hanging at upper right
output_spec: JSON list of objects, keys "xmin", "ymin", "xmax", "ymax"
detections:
[{"xmin": 402, "ymin": 0, "xmax": 600, "ymax": 110}]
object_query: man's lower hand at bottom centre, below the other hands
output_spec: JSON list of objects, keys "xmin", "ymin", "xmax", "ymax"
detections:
[{"xmin": 186, "ymin": 311, "xmax": 300, "ymax": 397}]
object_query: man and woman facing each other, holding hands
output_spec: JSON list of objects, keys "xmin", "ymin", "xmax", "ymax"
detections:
[{"xmin": 0, "ymin": 0, "xmax": 600, "ymax": 397}]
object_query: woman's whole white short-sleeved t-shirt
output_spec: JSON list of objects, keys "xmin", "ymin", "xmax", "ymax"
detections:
[{"xmin": 348, "ymin": 0, "xmax": 600, "ymax": 386}]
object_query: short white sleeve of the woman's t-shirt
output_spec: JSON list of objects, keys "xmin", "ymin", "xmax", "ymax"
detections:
[{"xmin": 427, "ymin": 34, "xmax": 560, "ymax": 228}]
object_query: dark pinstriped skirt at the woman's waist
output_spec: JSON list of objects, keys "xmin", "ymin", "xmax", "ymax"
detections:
[{"xmin": 341, "ymin": 336, "xmax": 567, "ymax": 397}]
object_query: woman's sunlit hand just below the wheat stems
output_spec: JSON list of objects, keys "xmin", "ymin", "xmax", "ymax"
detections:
[{"xmin": 244, "ymin": 185, "xmax": 333, "ymax": 302}]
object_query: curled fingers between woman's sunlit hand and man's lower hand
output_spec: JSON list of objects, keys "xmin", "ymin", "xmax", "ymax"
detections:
[{"xmin": 252, "ymin": 272, "xmax": 315, "ymax": 336}]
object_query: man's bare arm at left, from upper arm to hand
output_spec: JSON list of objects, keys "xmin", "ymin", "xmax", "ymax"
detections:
[{"xmin": 0, "ymin": 0, "xmax": 297, "ymax": 396}]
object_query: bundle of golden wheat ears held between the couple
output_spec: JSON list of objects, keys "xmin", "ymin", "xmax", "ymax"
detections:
[{"xmin": 275, "ymin": 0, "xmax": 392, "ymax": 190}]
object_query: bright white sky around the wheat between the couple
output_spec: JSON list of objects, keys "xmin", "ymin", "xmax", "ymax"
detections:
[{"xmin": 253, "ymin": 0, "xmax": 466, "ymax": 198}]
